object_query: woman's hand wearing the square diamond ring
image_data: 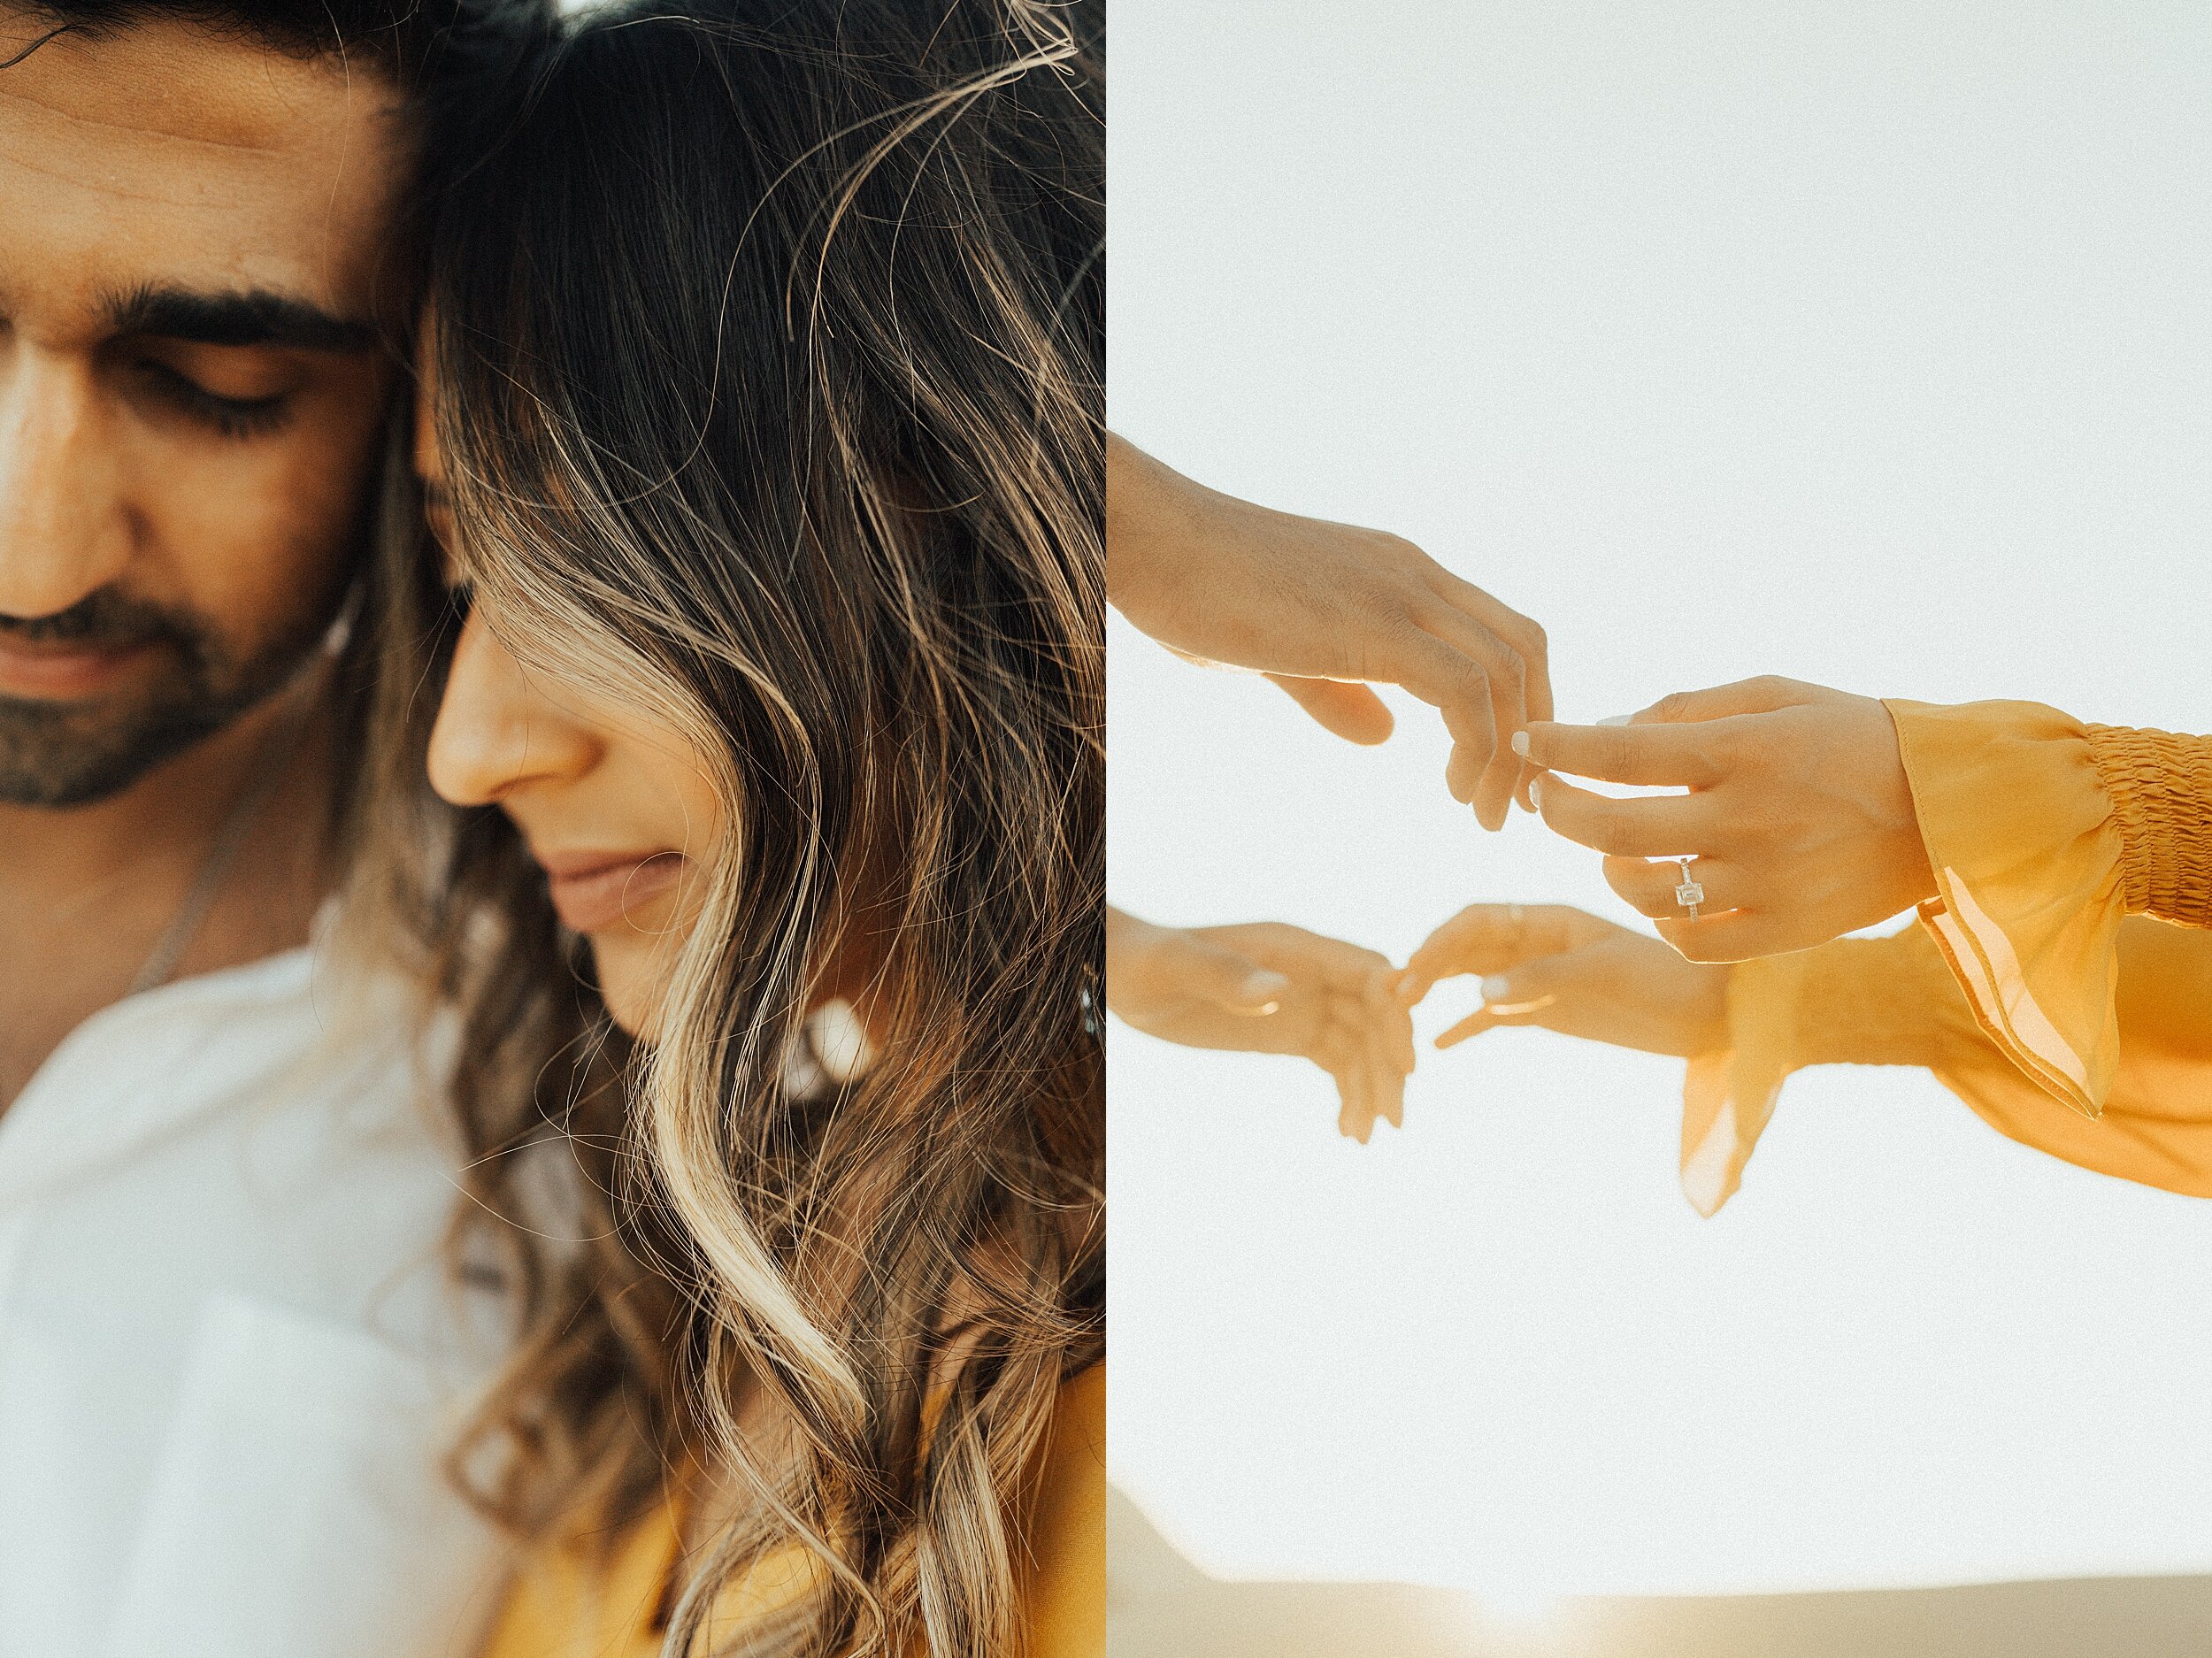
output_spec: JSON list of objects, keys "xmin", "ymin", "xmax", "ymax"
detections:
[{"xmin": 1526, "ymin": 679, "xmax": 1936, "ymax": 962}]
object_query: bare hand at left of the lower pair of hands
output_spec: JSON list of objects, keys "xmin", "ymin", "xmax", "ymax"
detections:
[{"xmin": 1106, "ymin": 909, "xmax": 1414, "ymax": 1145}]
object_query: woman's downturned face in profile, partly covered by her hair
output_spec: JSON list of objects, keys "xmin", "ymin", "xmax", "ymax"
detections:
[{"xmin": 416, "ymin": 376, "xmax": 724, "ymax": 1039}]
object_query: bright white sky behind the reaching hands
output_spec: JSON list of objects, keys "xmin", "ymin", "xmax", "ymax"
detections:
[{"xmin": 1110, "ymin": 0, "xmax": 2212, "ymax": 1592}]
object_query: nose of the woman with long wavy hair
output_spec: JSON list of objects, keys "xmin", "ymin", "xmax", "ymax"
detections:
[{"xmin": 429, "ymin": 615, "xmax": 600, "ymax": 807}]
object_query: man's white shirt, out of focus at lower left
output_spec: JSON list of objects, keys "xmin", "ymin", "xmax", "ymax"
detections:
[{"xmin": 0, "ymin": 946, "xmax": 500, "ymax": 1658}]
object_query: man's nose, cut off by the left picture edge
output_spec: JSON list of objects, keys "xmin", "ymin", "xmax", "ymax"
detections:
[{"xmin": 0, "ymin": 345, "xmax": 133, "ymax": 617}]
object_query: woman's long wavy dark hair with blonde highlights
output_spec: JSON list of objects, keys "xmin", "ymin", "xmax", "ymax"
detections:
[{"xmin": 361, "ymin": 0, "xmax": 1104, "ymax": 1658}]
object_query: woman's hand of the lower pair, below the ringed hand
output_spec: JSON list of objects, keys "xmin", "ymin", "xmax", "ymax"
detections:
[{"xmin": 1398, "ymin": 904, "xmax": 1728, "ymax": 1059}]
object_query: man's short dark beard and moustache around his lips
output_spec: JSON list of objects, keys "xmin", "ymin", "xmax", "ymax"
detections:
[{"xmin": 0, "ymin": 588, "xmax": 319, "ymax": 807}]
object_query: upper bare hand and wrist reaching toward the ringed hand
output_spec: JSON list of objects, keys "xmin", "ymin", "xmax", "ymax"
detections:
[{"xmin": 1106, "ymin": 435, "xmax": 1551, "ymax": 829}]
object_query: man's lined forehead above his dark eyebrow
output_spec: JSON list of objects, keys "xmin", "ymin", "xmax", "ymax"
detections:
[{"xmin": 0, "ymin": 6, "xmax": 407, "ymax": 326}]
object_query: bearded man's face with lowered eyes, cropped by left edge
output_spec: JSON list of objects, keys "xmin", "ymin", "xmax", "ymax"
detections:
[{"xmin": 0, "ymin": 0, "xmax": 407, "ymax": 807}]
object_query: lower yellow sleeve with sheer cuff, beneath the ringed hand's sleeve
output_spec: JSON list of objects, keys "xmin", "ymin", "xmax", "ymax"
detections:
[{"xmin": 1681, "ymin": 917, "xmax": 2212, "ymax": 1214}]
